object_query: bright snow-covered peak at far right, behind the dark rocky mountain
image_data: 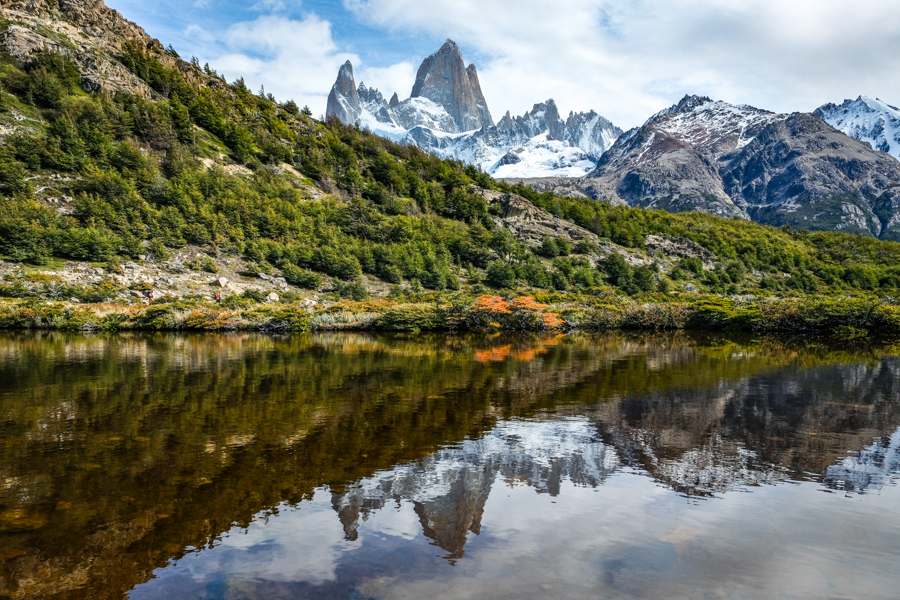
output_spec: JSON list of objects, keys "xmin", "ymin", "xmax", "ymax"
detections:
[{"xmin": 815, "ymin": 96, "xmax": 900, "ymax": 159}]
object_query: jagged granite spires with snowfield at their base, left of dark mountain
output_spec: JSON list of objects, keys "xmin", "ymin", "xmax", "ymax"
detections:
[{"xmin": 326, "ymin": 40, "xmax": 622, "ymax": 177}]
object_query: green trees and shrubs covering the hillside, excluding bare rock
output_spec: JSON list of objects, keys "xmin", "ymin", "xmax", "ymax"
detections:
[{"xmin": 0, "ymin": 45, "xmax": 900, "ymax": 329}]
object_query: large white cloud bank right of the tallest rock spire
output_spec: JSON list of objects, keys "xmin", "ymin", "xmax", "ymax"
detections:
[{"xmin": 344, "ymin": 0, "xmax": 900, "ymax": 126}]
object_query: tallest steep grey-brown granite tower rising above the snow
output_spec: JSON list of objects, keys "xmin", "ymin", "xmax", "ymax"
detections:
[{"xmin": 411, "ymin": 40, "xmax": 494, "ymax": 133}]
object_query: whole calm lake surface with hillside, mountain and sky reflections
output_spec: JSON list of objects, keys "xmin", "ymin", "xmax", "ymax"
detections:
[{"xmin": 0, "ymin": 333, "xmax": 900, "ymax": 600}]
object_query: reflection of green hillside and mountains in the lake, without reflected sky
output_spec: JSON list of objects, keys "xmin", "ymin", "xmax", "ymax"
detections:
[{"xmin": 0, "ymin": 333, "xmax": 900, "ymax": 598}]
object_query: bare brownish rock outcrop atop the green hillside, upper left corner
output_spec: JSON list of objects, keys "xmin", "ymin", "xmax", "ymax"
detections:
[{"xmin": 0, "ymin": 0, "xmax": 192, "ymax": 97}]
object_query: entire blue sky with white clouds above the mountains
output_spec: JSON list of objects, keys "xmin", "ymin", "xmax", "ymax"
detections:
[{"xmin": 106, "ymin": 0, "xmax": 900, "ymax": 129}]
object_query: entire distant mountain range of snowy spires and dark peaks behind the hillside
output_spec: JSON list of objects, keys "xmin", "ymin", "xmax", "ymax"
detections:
[{"xmin": 328, "ymin": 45, "xmax": 900, "ymax": 240}]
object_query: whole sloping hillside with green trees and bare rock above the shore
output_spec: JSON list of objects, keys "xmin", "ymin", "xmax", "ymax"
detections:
[{"xmin": 0, "ymin": 0, "xmax": 900, "ymax": 314}]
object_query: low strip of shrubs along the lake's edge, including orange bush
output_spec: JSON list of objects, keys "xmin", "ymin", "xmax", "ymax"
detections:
[{"xmin": 0, "ymin": 295, "xmax": 900, "ymax": 338}]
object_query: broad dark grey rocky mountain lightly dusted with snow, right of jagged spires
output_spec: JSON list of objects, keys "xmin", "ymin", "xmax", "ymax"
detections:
[{"xmin": 587, "ymin": 96, "xmax": 900, "ymax": 240}]
